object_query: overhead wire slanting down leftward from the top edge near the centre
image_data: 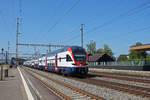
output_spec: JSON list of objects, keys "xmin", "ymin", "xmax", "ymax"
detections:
[{"xmin": 48, "ymin": 0, "xmax": 80, "ymax": 32}]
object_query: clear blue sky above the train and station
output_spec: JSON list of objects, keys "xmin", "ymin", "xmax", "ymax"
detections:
[{"xmin": 0, "ymin": 0, "xmax": 150, "ymax": 56}]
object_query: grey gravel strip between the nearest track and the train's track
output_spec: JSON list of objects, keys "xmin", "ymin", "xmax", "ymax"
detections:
[{"xmin": 28, "ymin": 70, "xmax": 149, "ymax": 100}]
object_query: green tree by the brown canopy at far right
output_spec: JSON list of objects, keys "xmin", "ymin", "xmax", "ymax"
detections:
[{"xmin": 129, "ymin": 42, "xmax": 147, "ymax": 60}]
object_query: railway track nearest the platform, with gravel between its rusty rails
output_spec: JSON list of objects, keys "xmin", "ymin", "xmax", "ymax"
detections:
[{"xmin": 24, "ymin": 68, "xmax": 105, "ymax": 100}]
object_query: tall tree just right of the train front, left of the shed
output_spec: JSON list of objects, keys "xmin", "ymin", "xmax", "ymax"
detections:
[{"xmin": 86, "ymin": 40, "xmax": 96, "ymax": 54}]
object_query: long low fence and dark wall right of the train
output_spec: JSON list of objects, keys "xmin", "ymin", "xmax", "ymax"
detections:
[{"xmin": 88, "ymin": 60, "xmax": 150, "ymax": 71}]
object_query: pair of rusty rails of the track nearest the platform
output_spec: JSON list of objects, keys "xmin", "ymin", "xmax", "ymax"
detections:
[{"xmin": 24, "ymin": 68, "xmax": 104, "ymax": 100}]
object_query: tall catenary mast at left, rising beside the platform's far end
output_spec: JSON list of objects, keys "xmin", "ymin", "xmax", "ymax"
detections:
[{"xmin": 16, "ymin": 18, "xmax": 20, "ymax": 66}]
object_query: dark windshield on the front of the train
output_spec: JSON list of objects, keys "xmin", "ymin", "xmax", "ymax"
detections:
[{"xmin": 72, "ymin": 47, "xmax": 86, "ymax": 61}]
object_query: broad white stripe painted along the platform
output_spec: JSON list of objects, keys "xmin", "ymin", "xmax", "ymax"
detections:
[{"xmin": 17, "ymin": 67, "xmax": 34, "ymax": 100}]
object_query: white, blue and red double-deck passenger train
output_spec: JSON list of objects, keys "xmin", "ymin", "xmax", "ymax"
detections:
[{"xmin": 24, "ymin": 46, "xmax": 88, "ymax": 75}]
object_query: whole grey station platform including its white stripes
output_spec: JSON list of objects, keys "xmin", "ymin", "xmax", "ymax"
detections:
[{"xmin": 0, "ymin": 67, "xmax": 61, "ymax": 100}]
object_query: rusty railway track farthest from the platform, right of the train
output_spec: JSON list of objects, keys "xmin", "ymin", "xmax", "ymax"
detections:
[{"xmin": 89, "ymin": 72, "xmax": 150, "ymax": 84}]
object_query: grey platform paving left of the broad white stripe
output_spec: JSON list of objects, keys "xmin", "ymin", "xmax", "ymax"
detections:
[{"xmin": 0, "ymin": 68, "xmax": 28, "ymax": 100}]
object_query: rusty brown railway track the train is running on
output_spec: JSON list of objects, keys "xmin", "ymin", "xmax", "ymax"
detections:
[{"xmin": 23, "ymin": 69, "xmax": 150, "ymax": 99}]
